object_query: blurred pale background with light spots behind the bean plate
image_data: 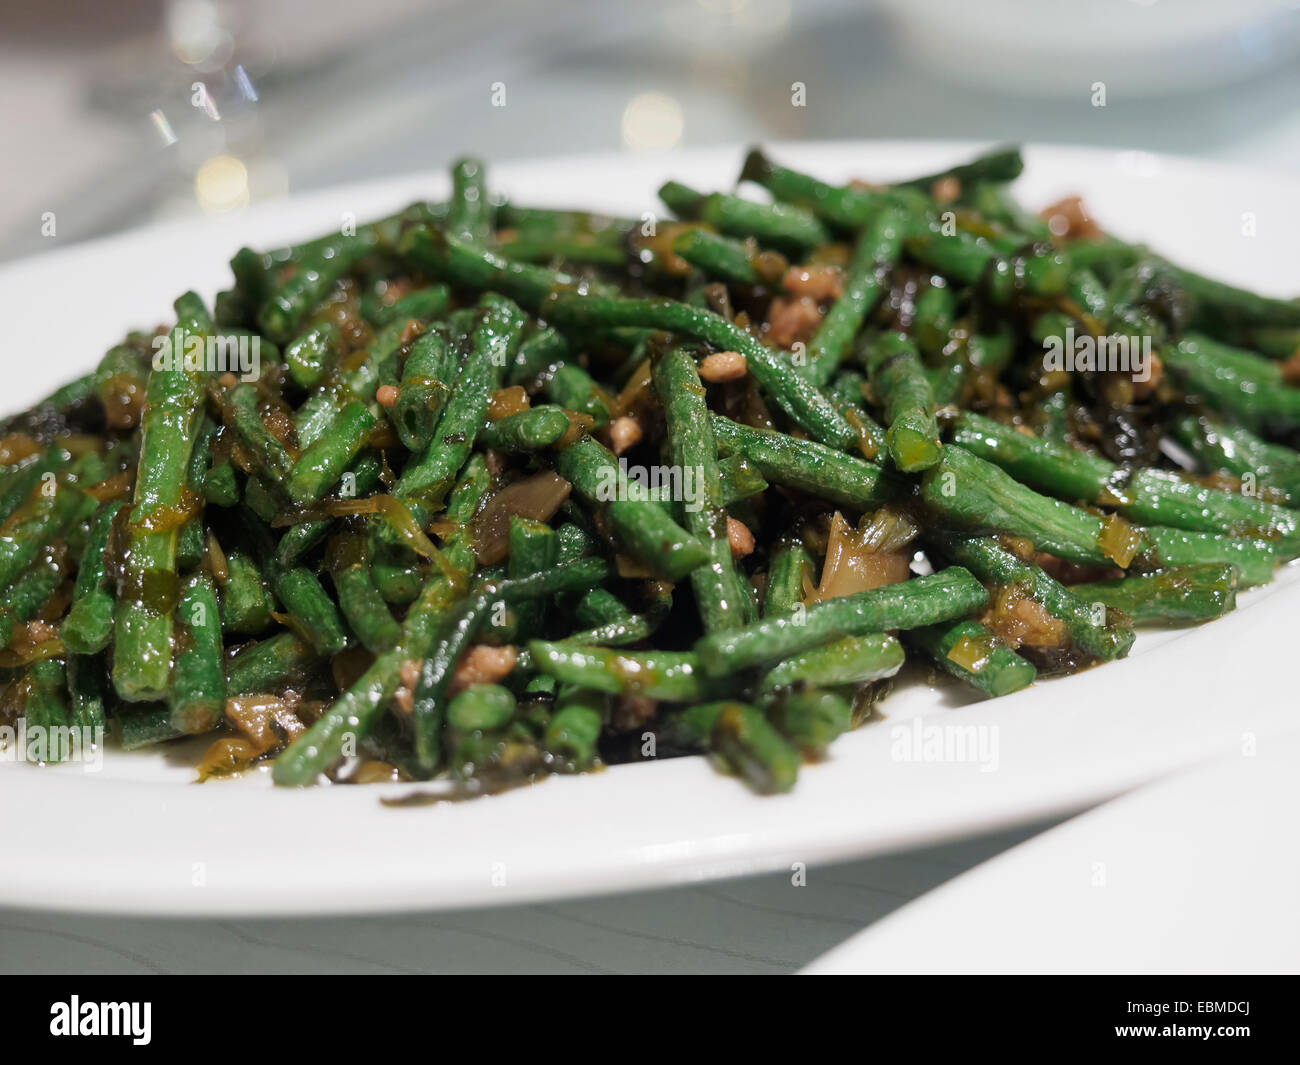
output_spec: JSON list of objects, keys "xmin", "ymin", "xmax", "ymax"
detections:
[{"xmin": 0, "ymin": 0, "xmax": 1300, "ymax": 257}]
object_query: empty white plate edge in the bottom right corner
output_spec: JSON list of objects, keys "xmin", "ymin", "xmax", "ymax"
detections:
[{"xmin": 802, "ymin": 735, "xmax": 1300, "ymax": 972}]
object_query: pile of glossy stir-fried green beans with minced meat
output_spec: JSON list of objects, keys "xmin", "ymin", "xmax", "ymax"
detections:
[{"xmin": 0, "ymin": 148, "xmax": 1300, "ymax": 793}]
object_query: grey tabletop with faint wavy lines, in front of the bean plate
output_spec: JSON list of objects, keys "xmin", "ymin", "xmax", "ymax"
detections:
[{"xmin": 0, "ymin": 823, "xmax": 1050, "ymax": 974}]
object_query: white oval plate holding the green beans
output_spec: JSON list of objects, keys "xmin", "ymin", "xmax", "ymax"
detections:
[{"xmin": 0, "ymin": 142, "xmax": 1300, "ymax": 917}]
